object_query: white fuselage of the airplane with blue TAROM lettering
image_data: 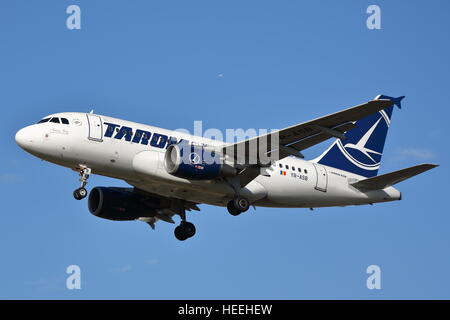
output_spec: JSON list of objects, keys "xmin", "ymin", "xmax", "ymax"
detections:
[{"xmin": 16, "ymin": 113, "xmax": 401, "ymax": 208}]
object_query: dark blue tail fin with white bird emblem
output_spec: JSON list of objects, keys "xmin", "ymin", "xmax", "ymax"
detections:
[{"xmin": 316, "ymin": 95, "xmax": 404, "ymax": 177}]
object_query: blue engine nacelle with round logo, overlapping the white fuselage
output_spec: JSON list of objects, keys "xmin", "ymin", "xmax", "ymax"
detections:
[{"xmin": 164, "ymin": 144, "xmax": 236, "ymax": 180}]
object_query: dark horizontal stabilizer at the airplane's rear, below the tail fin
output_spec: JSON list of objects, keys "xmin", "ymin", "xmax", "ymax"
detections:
[{"xmin": 351, "ymin": 163, "xmax": 438, "ymax": 190}]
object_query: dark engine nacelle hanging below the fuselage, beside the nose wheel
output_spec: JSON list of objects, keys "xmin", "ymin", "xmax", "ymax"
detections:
[{"xmin": 88, "ymin": 187, "xmax": 155, "ymax": 221}]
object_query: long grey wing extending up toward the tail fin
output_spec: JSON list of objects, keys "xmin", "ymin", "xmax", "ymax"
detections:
[{"xmin": 222, "ymin": 99, "xmax": 395, "ymax": 186}]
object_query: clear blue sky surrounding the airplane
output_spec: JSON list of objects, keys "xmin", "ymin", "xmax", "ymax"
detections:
[{"xmin": 0, "ymin": 0, "xmax": 450, "ymax": 299}]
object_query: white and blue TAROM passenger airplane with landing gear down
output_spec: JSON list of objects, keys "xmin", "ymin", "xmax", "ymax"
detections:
[{"xmin": 15, "ymin": 95, "xmax": 437, "ymax": 241}]
